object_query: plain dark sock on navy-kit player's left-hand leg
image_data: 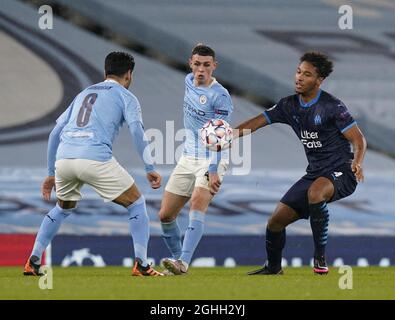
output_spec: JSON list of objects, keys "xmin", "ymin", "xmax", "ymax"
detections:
[{"xmin": 266, "ymin": 227, "xmax": 285, "ymax": 272}]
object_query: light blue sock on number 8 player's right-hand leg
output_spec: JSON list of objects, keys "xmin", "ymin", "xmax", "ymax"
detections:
[{"xmin": 127, "ymin": 195, "xmax": 150, "ymax": 266}]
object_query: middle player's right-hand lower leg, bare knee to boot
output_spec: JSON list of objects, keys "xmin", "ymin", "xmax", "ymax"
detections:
[{"xmin": 163, "ymin": 187, "xmax": 213, "ymax": 275}]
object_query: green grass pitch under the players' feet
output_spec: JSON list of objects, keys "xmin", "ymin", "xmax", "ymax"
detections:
[{"xmin": 0, "ymin": 267, "xmax": 395, "ymax": 300}]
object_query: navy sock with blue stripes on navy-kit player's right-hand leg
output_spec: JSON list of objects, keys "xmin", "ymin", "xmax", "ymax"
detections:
[{"xmin": 309, "ymin": 201, "xmax": 329, "ymax": 257}]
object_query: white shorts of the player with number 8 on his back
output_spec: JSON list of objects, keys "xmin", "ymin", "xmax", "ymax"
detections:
[{"xmin": 55, "ymin": 158, "xmax": 134, "ymax": 202}]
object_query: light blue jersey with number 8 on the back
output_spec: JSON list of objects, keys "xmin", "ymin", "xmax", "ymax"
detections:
[{"xmin": 56, "ymin": 80, "xmax": 142, "ymax": 162}]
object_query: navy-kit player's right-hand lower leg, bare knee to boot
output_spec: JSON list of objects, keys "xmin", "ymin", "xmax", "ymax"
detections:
[{"xmin": 307, "ymin": 177, "xmax": 334, "ymax": 275}]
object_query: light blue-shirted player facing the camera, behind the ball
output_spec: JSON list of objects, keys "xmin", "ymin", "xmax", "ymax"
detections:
[{"xmin": 159, "ymin": 44, "xmax": 233, "ymax": 275}]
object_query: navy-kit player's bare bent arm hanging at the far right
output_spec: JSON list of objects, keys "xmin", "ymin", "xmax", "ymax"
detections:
[{"xmin": 343, "ymin": 125, "xmax": 367, "ymax": 182}]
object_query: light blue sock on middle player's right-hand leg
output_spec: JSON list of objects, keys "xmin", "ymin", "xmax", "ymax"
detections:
[{"xmin": 180, "ymin": 210, "xmax": 205, "ymax": 264}]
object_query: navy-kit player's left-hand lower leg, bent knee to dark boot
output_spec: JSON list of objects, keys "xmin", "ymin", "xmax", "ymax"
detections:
[{"xmin": 248, "ymin": 202, "xmax": 300, "ymax": 275}]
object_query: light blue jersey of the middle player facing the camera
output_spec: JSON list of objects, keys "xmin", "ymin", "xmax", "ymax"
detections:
[{"xmin": 183, "ymin": 73, "xmax": 233, "ymax": 159}]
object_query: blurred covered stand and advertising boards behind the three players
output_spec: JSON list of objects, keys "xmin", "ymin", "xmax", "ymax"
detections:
[{"xmin": 0, "ymin": 0, "xmax": 395, "ymax": 267}]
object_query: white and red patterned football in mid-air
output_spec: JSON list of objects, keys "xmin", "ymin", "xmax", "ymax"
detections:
[{"xmin": 200, "ymin": 119, "xmax": 233, "ymax": 151}]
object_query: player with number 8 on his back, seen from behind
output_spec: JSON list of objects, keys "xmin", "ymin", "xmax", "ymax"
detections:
[{"xmin": 24, "ymin": 52, "xmax": 163, "ymax": 276}]
